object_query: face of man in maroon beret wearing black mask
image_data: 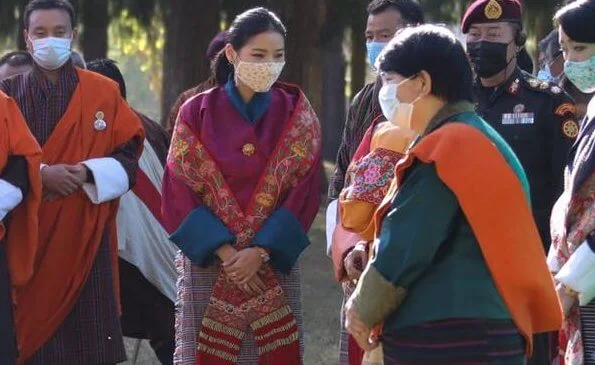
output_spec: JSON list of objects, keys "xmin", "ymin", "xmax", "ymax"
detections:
[{"xmin": 467, "ymin": 22, "xmax": 519, "ymax": 79}]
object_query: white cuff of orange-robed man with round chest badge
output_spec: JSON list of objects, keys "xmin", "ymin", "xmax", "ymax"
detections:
[{"xmin": 83, "ymin": 157, "xmax": 130, "ymax": 204}]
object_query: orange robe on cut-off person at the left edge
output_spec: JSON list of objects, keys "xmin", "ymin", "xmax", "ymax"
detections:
[{"xmin": 0, "ymin": 91, "xmax": 41, "ymax": 287}]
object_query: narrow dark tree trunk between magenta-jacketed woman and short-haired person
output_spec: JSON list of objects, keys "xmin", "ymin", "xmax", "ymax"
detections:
[{"xmin": 321, "ymin": 0, "xmax": 346, "ymax": 161}]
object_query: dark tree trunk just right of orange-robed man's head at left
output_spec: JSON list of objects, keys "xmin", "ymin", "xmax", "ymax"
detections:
[{"xmin": 81, "ymin": 0, "xmax": 110, "ymax": 61}]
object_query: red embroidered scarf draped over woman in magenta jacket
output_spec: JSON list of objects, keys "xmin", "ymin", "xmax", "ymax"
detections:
[{"xmin": 168, "ymin": 86, "xmax": 321, "ymax": 365}]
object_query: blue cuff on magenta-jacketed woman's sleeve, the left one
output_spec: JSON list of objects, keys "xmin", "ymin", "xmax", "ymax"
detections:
[{"xmin": 169, "ymin": 206, "xmax": 235, "ymax": 267}]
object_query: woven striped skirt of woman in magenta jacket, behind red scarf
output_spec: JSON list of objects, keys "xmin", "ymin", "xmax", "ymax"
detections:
[{"xmin": 174, "ymin": 253, "xmax": 304, "ymax": 365}]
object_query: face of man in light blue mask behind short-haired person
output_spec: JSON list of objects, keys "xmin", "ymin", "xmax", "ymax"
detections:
[{"xmin": 366, "ymin": 8, "xmax": 405, "ymax": 67}]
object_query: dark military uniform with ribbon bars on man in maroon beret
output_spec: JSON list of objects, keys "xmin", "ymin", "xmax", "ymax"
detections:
[{"xmin": 477, "ymin": 69, "xmax": 579, "ymax": 247}]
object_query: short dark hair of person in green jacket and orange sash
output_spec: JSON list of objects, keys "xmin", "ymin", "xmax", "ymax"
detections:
[{"xmin": 379, "ymin": 24, "xmax": 473, "ymax": 103}]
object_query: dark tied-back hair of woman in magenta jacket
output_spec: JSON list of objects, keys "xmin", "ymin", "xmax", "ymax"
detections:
[{"xmin": 213, "ymin": 8, "xmax": 287, "ymax": 85}]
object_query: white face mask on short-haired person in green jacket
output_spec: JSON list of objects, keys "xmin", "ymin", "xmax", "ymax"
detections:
[{"xmin": 378, "ymin": 77, "xmax": 421, "ymax": 129}]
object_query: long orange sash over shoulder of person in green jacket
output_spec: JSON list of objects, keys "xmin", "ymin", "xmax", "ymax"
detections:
[{"xmin": 375, "ymin": 122, "xmax": 563, "ymax": 354}]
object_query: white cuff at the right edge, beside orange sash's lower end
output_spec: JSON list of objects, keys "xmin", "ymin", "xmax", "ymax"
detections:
[{"xmin": 556, "ymin": 241, "xmax": 595, "ymax": 305}]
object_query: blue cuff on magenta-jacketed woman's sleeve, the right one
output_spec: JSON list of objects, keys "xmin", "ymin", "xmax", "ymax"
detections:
[{"xmin": 254, "ymin": 208, "xmax": 310, "ymax": 274}]
